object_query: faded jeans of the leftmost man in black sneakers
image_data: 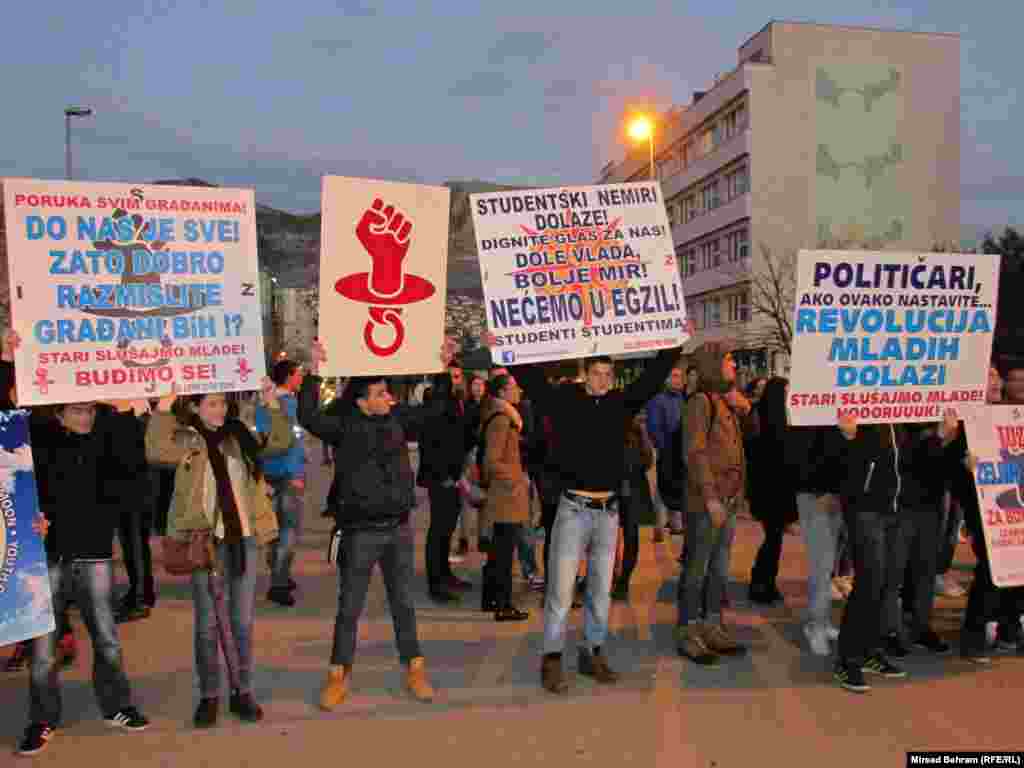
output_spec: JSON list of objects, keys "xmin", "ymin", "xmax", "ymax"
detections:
[{"xmin": 29, "ymin": 560, "xmax": 131, "ymax": 726}]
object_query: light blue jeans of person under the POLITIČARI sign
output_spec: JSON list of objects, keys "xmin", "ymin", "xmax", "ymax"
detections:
[{"xmin": 797, "ymin": 494, "xmax": 843, "ymax": 627}]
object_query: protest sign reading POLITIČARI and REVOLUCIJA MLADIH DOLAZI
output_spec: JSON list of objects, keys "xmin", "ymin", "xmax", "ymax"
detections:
[{"xmin": 790, "ymin": 251, "xmax": 999, "ymax": 426}]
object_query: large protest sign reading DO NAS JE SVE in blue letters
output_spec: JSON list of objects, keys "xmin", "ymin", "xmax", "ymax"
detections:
[{"xmin": 3, "ymin": 179, "xmax": 266, "ymax": 406}]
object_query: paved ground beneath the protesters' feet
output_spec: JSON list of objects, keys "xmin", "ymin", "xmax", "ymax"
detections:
[{"xmin": 0, "ymin": 443, "xmax": 1024, "ymax": 768}]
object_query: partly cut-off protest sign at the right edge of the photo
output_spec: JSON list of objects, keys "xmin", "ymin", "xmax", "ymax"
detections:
[{"xmin": 964, "ymin": 406, "xmax": 1024, "ymax": 587}]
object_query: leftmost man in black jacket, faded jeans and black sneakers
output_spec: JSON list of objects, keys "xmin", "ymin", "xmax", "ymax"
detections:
[{"xmin": 18, "ymin": 402, "xmax": 148, "ymax": 755}]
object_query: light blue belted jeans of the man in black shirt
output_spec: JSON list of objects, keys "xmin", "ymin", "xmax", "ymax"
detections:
[{"xmin": 544, "ymin": 496, "xmax": 618, "ymax": 653}]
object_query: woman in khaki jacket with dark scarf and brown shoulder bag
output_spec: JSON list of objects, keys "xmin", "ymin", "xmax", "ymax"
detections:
[{"xmin": 145, "ymin": 379, "xmax": 292, "ymax": 728}]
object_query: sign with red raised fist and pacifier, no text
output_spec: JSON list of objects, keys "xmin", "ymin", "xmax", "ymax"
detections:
[{"xmin": 319, "ymin": 176, "xmax": 451, "ymax": 376}]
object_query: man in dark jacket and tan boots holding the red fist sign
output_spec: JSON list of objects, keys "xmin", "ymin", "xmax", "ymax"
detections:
[{"xmin": 298, "ymin": 342, "xmax": 451, "ymax": 711}]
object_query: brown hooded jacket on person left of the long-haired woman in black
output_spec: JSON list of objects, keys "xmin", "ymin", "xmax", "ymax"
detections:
[{"xmin": 686, "ymin": 342, "xmax": 754, "ymax": 509}]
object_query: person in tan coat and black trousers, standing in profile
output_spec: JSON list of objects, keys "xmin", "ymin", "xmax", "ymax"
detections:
[{"xmin": 480, "ymin": 375, "xmax": 529, "ymax": 622}]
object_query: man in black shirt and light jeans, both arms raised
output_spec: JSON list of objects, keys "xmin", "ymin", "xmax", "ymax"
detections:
[{"xmin": 513, "ymin": 348, "xmax": 679, "ymax": 693}]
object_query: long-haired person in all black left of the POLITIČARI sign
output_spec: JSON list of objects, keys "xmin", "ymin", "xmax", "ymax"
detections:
[{"xmin": 748, "ymin": 377, "xmax": 799, "ymax": 604}]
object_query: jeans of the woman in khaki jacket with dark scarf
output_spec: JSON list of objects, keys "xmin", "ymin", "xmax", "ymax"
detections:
[{"xmin": 191, "ymin": 537, "xmax": 256, "ymax": 698}]
